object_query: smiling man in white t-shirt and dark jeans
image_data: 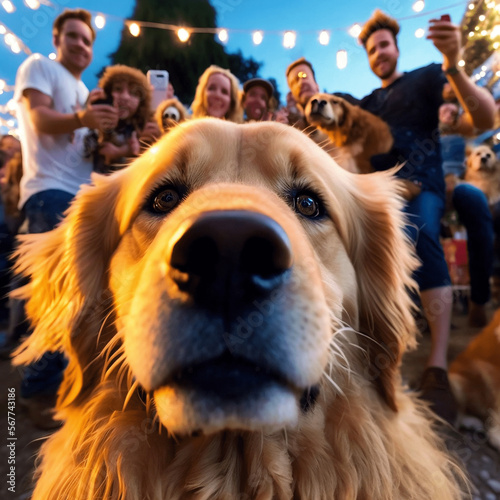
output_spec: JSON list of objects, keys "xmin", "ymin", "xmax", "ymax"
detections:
[{"xmin": 11, "ymin": 9, "xmax": 118, "ymax": 428}]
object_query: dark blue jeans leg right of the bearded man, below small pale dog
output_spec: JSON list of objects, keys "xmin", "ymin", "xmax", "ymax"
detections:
[{"xmin": 452, "ymin": 184, "xmax": 493, "ymax": 304}]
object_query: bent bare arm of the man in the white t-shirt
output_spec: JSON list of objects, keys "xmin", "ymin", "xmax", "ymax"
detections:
[{"xmin": 23, "ymin": 89, "xmax": 118, "ymax": 135}]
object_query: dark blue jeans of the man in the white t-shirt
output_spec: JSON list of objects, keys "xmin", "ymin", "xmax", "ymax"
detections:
[{"xmin": 21, "ymin": 189, "xmax": 74, "ymax": 398}]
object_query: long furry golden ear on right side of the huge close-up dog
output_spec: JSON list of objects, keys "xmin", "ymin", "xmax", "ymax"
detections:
[{"xmin": 346, "ymin": 172, "xmax": 418, "ymax": 411}]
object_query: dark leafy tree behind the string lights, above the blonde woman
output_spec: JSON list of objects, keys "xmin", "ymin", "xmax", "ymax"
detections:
[{"xmin": 106, "ymin": 0, "xmax": 261, "ymax": 104}]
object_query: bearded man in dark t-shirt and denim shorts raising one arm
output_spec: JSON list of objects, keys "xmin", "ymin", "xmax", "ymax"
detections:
[{"xmin": 359, "ymin": 9, "xmax": 494, "ymax": 423}]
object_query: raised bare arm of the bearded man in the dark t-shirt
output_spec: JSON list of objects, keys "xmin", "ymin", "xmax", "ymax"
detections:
[{"xmin": 427, "ymin": 19, "xmax": 495, "ymax": 130}]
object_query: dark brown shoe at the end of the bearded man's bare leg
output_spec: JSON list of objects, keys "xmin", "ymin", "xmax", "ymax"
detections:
[{"xmin": 418, "ymin": 366, "xmax": 458, "ymax": 426}]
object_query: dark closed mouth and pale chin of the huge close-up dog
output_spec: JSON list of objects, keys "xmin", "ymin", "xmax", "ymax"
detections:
[{"xmin": 154, "ymin": 352, "xmax": 318, "ymax": 435}]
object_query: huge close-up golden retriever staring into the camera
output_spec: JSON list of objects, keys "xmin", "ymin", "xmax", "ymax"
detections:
[{"xmin": 15, "ymin": 118, "xmax": 460, "ymax": 500}]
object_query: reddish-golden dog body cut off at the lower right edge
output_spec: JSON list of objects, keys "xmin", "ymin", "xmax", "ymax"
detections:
[{"xmin": 449, "ymin": 309, "xmax": 500, "ymax": 451}]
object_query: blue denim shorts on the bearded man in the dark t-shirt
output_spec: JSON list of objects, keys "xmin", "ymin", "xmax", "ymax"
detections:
[{"xmin": 405, "ymin": 191, "xmax": 451, "ymax": 292}]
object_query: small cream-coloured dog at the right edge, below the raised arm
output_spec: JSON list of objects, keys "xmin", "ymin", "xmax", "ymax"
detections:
[{"xmin": 465, "ymin": 144, "xmax": 500, "ymax": 205}]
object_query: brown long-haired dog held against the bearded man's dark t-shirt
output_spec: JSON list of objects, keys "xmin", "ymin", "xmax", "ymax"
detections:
[{"xmin": 305, "ymin": 94, "xmax": 393, "ymax": 174}]
